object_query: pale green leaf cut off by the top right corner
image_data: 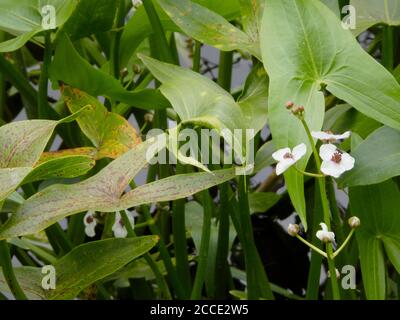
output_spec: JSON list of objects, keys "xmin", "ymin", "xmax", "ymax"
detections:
[{"xmin": 350, "ymin": 0, "xmax": 400, "ymax": 35}]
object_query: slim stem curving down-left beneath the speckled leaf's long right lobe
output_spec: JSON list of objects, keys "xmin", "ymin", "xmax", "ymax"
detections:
[{"xmin": 191, "ymin": 190, "xmax": 212, "ymax": 300}]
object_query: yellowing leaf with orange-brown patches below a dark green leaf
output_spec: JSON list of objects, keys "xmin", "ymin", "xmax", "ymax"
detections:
[{"xmin": 63, "ymin": 86, "xmax": 140, "ymax": 159}]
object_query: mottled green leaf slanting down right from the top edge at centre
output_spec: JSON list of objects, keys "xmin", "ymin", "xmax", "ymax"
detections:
[{"xmin": 158, "ymin": 0, "xmax": 260, "ymax": 57}]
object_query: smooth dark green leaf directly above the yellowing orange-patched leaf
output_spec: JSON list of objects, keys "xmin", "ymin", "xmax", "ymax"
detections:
[{"xmin": 50, "ymin": 33, "xmax": 168, "ymax": 110}]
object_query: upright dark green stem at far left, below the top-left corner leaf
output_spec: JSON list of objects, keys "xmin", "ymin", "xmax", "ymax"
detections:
[{"xmin": 38, "ymin": 31, "xmax": 52, "ymax": 119}]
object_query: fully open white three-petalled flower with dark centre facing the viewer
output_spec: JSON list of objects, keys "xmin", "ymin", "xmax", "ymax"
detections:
[{"xmin": 319, "ymin": 143, "xmax": 355, "ymax": 178}]
